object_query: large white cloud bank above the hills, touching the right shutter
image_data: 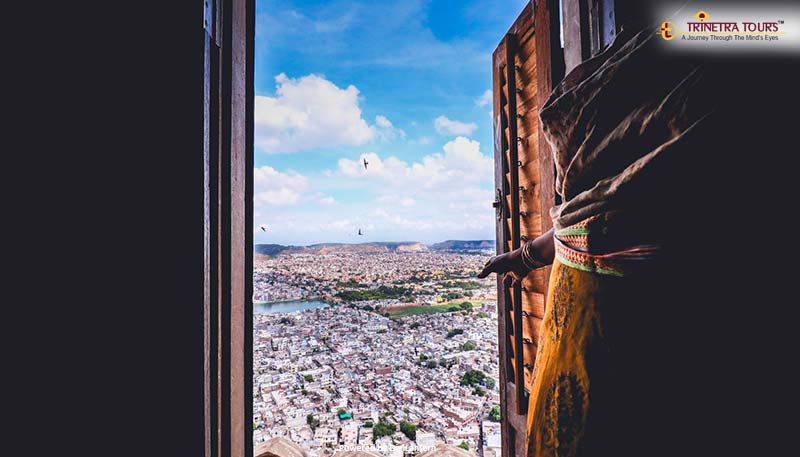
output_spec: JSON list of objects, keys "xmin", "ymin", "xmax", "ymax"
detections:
[{"xmin": 310, "ymin": 136, "xmax": 494, "ymax": 242}]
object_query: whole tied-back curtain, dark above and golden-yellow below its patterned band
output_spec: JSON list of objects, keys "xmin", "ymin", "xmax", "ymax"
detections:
[{"xmin": 526, "ymin": 24, "xmax": 719, "ymax": 457}]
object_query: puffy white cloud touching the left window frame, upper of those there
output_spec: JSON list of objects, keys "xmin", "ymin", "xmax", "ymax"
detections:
[{"xmin": 255, "ymin": 73, "xmax": 378, "ymax": 153}]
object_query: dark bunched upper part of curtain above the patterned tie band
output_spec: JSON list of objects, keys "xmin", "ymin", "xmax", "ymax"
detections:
[{"xmin": 539, "ymin": 25, "xmax": 716, "ymax": 229}]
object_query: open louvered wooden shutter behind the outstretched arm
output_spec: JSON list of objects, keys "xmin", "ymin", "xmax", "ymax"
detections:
[{"xmin": 492, "ymin": 1, "xmax": 563, "ymax": 456}]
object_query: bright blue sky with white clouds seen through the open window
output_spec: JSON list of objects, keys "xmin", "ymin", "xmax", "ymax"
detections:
[{"xmin": 254, "ymin": 0, "xmax": 527, "ymax": 245}]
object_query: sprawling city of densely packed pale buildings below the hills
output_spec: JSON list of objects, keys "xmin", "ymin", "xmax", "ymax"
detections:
[{"xmin": 253, "ymin": 246, "xmax": 500, "ymax": 457}]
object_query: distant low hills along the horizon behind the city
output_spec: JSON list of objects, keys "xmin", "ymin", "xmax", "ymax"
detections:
[{"xmin": 254, "ymin": 240, "xmax": 495, "ymax": 255}]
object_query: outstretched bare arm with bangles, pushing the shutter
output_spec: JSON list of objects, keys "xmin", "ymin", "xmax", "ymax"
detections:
[{"xmin": 478, "ymin": 229, "xmax": 555, "ymax": 286}]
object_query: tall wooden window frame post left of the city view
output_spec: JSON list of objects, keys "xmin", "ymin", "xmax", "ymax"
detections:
[{"xmin": 203, "ymin": 0, "xmax": 255, "ymax": 457}]
